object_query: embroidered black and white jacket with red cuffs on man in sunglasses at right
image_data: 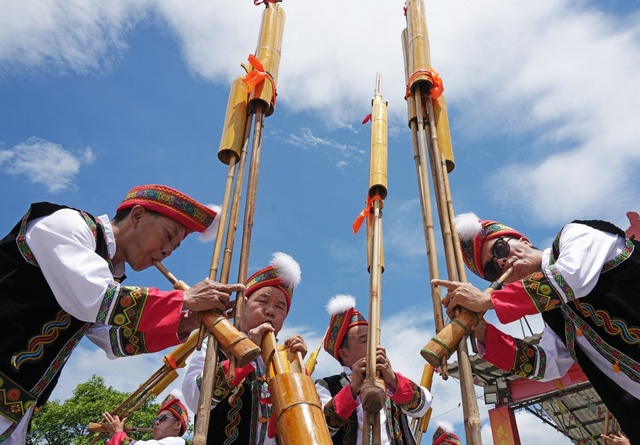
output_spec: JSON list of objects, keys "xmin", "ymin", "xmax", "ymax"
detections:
[{"xmin": 483, "ymin": 221, "xmax": 640, "ymax": 443}]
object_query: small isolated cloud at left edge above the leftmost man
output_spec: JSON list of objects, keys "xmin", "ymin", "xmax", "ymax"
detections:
[{"xmin": 0, "ymin": 137, "xmax": 95, "ymax": 193}]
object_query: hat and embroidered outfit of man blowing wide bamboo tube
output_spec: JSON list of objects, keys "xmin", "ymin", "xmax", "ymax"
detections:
[{"xmin": 182, "ymin": 252, "xmax": 300, "ymax": 445}]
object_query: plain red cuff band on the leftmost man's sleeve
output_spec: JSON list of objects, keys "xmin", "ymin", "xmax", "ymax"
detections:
[{"xmin": 138, "ymin": 287, "xmax": 184, "ymax": 335}]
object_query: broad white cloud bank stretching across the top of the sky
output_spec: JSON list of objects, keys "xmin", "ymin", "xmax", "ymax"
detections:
[{"xmin": 0, "ymin": 0, "xmax": 640, "ymax": 225}]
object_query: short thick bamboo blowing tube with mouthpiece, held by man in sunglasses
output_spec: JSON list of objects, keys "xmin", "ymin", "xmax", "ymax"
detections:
[{"xmin": 420, "ymin": 267, "xmax": 513, "ymax": 366}]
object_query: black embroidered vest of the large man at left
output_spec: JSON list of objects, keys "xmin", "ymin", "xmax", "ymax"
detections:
[{"xmin": 0, "ymin": 202, "xmax": 108, "ymax": 421}]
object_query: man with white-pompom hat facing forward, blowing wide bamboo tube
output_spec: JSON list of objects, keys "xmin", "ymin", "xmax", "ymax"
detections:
[{"xmin": 182, "ymin": 252, "xmax": 307, "ymax": 445}]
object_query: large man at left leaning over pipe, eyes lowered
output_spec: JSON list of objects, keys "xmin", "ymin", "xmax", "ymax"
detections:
[{"xmin": 0, "ymin": 185, "xmax": 244, "ymax": 445}]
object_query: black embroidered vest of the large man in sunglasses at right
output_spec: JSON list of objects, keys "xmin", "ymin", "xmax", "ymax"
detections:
[{"xmin": 542, "ymin": 221, "xmax": 640, "ymax": 443}]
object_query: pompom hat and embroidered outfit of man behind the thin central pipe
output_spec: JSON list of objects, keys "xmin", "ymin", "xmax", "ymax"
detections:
[{"xmin": 316, "ymin": 295, "xmax": 432, "ymax": 445}]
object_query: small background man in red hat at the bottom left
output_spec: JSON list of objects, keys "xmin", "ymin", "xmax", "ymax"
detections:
[{"xmin": 102, "ymin": 394, "xmax": 189, "ymax": 445}]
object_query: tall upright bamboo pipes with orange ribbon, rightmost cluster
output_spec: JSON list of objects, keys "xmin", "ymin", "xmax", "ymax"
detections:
[{"xmin": 403, "ymin": 0, "xmax": 482, "ymax": 445}]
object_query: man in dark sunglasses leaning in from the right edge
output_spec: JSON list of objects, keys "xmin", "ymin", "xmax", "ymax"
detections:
[{"xmin": 432, "ymin": 214, "xmax": 640, "ymax": 444}]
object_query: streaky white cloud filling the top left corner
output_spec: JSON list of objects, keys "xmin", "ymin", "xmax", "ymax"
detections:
[{"xmin": 0, "ymin": 0, "xmax": 148, "ymax": 75}]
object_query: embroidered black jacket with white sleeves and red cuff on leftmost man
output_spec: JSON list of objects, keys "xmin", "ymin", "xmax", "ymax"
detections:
[{"xmin": 0, "ymin": 203, "xmax": 188, "ymax": 442}]
